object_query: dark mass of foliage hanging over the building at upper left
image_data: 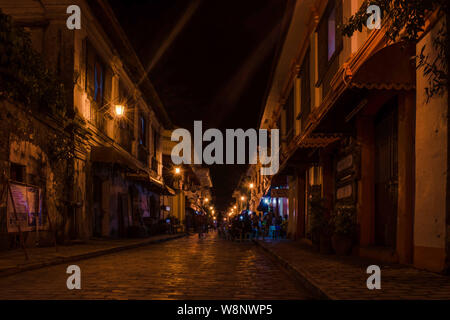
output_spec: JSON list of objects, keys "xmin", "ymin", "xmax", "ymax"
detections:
[{"xmin": 0, "ymin": 10, "xmax": 66, "ymax": 115}]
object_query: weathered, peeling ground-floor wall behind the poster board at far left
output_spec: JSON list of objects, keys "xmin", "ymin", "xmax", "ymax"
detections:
[{"xmin": 0, "ymin": 101, "xmax": 69, "ymax": 249}]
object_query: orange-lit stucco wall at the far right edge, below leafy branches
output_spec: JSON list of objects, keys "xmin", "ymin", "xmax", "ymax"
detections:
[{"xmin": 414, "ymin": 16, "xmax": 448, "ymax": 271}]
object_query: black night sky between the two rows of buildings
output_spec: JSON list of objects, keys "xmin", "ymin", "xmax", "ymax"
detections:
[{"xmin": 109, "ymin": 0, "xmax": 286, "ymax": 210}]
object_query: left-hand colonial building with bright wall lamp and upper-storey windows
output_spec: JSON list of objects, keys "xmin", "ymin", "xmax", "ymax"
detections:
[{"xmin": 0, "ymin": 0, "xmax": 172, "ymax": 247}]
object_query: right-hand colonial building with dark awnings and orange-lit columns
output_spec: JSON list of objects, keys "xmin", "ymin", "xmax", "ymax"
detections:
[{"xmin": 249, "ymin": 0, "xmax": 450, "ymax": 271}]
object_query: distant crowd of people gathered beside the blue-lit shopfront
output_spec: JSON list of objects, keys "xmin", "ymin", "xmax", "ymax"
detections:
[{"xmin": 219, "ymin": 210, "xmax": 288, "ymax": 240}]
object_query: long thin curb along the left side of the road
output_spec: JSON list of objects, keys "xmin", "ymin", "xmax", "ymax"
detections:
[{"xmin": 0, "ymin": 233, "xmax": 188, "ymax": 278}]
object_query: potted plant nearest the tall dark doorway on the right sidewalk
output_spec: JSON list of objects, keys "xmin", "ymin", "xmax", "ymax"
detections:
[{"xmin": 331, "ymin": 205, "xmax": 356, "ymax": 255}]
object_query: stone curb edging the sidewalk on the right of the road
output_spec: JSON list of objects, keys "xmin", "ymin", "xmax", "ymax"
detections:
[{"xmin": 253, "ymin": 240, "xmax": 338, "ymax": 300}]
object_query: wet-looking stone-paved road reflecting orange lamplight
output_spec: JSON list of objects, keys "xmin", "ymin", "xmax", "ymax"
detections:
[{"xmin": 0, "ymin": 234, "xmax": 309, "ymax": 299}]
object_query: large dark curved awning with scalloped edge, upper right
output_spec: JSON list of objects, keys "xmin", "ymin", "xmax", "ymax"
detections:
[{"xmin": 349, "ymin": 42, "xmax": 416, "ymax": 90}]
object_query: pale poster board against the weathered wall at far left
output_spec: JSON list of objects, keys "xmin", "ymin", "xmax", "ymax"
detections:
[{"xmin": 7, "ymin": 183, "xmax": 44, "ymax": 233}]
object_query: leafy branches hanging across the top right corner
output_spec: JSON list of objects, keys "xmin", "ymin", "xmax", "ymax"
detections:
[{"xmin": 341, "ymin": 0, "xmax": 450, "ymax": 99}]
